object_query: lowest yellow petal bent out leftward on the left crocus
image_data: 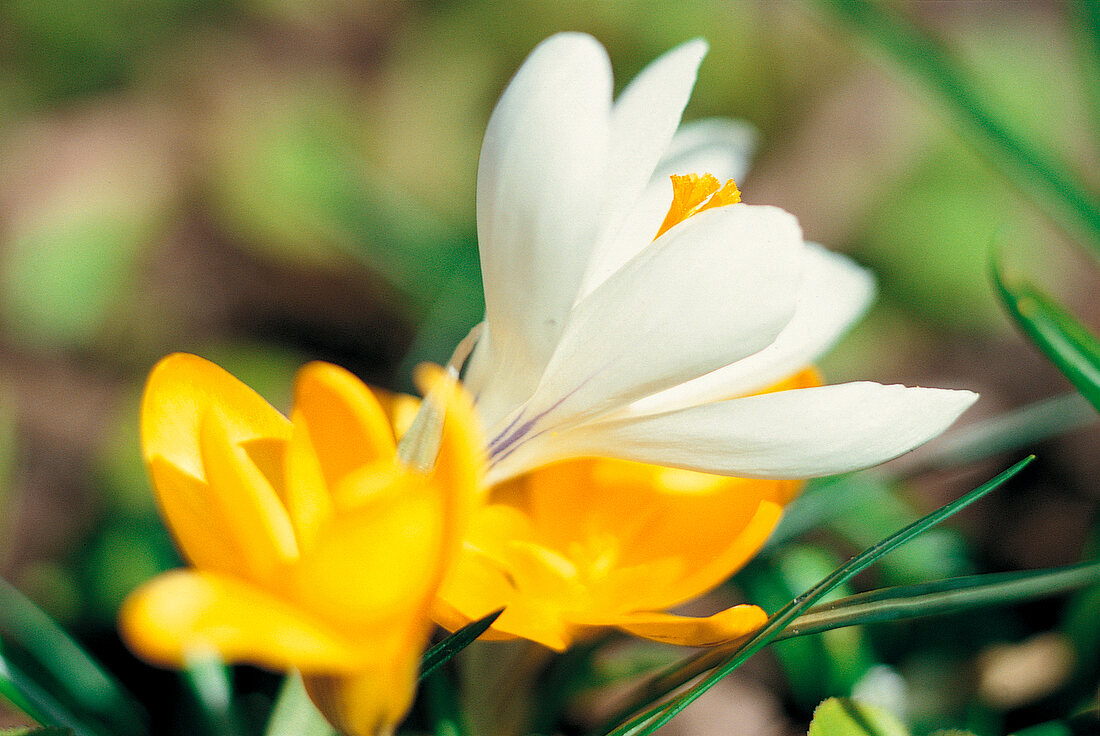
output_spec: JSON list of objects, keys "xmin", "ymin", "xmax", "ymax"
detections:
[{"xmin": 119, "ymin": 570, "xmax": 367, "ymax": 672}]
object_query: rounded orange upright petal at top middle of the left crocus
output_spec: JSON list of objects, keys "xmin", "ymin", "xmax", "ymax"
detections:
[{"xmin": 294, "ymin": 363, "xmax": 394, "ymax": 487}]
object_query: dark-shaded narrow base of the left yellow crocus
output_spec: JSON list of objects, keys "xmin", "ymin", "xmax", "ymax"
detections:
[{"xmin": 304, "ymin": 647, "xmax": 420, "ymax": 736}]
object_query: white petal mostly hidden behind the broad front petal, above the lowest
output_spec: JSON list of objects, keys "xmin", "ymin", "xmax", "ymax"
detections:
[{"xmin": 628, "ymin": 243, "xmax": 875, "ymax": 415}]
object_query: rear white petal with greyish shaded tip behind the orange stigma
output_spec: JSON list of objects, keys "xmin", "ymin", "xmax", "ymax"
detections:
[{"xmin": 581, "ymin": 118, "xmax": 756, "ymax": 297}]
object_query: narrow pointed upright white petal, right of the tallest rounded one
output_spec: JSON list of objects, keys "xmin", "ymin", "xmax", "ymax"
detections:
[{"xmin": 581, "ymin": 40, "xmax": 706, "ymax": 296}]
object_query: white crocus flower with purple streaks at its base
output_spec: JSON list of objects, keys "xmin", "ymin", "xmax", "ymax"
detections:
[{"xmin": 466, "ymin": 33, "xmax": 977, "ymax": 482}]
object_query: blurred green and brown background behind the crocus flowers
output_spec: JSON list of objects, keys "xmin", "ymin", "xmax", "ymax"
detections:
[{"xmin": 0, "ymin": 0, "xmax": 1100, "ymax": 734}]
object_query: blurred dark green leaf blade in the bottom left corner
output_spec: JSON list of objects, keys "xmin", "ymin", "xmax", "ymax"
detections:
[{"xmin": 0, "ymin": 579, "xmax": 146, "ymax": 734}]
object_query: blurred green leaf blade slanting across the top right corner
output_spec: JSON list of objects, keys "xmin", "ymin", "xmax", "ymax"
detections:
[{"xmin": 812, "ymin": 0, "xmax": 1100, "ymax": 257}]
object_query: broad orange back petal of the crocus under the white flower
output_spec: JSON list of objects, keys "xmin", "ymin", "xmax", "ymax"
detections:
[{"xmin": 521, "ymin": 458, "xmax": 791, "ymax": 611}]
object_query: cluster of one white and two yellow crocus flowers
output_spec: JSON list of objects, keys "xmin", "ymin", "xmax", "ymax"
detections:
[{"xmin": 122, "ymin": 34, "xmax": 976, "ymax": 734}]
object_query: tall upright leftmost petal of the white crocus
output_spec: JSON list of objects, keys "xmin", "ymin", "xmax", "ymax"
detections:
[{"xmin": 477, "ymin": 33, "xmax": 612, "ymax": 389}]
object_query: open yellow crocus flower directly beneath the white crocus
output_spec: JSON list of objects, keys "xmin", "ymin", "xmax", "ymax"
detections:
[{"xmin": 436, "ymin": 369, "xmax": 820, "ymax": 651}]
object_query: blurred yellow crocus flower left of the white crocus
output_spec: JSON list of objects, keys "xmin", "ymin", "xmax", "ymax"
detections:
[{"xmin": 120, "ymin": 354, "xmax": 484, "ymax": 736}]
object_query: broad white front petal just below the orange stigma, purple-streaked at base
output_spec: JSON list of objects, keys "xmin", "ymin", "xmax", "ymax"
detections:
[{"xmin": 494, "ymin": 205, "xmax": 803, "ymax": 452}]
